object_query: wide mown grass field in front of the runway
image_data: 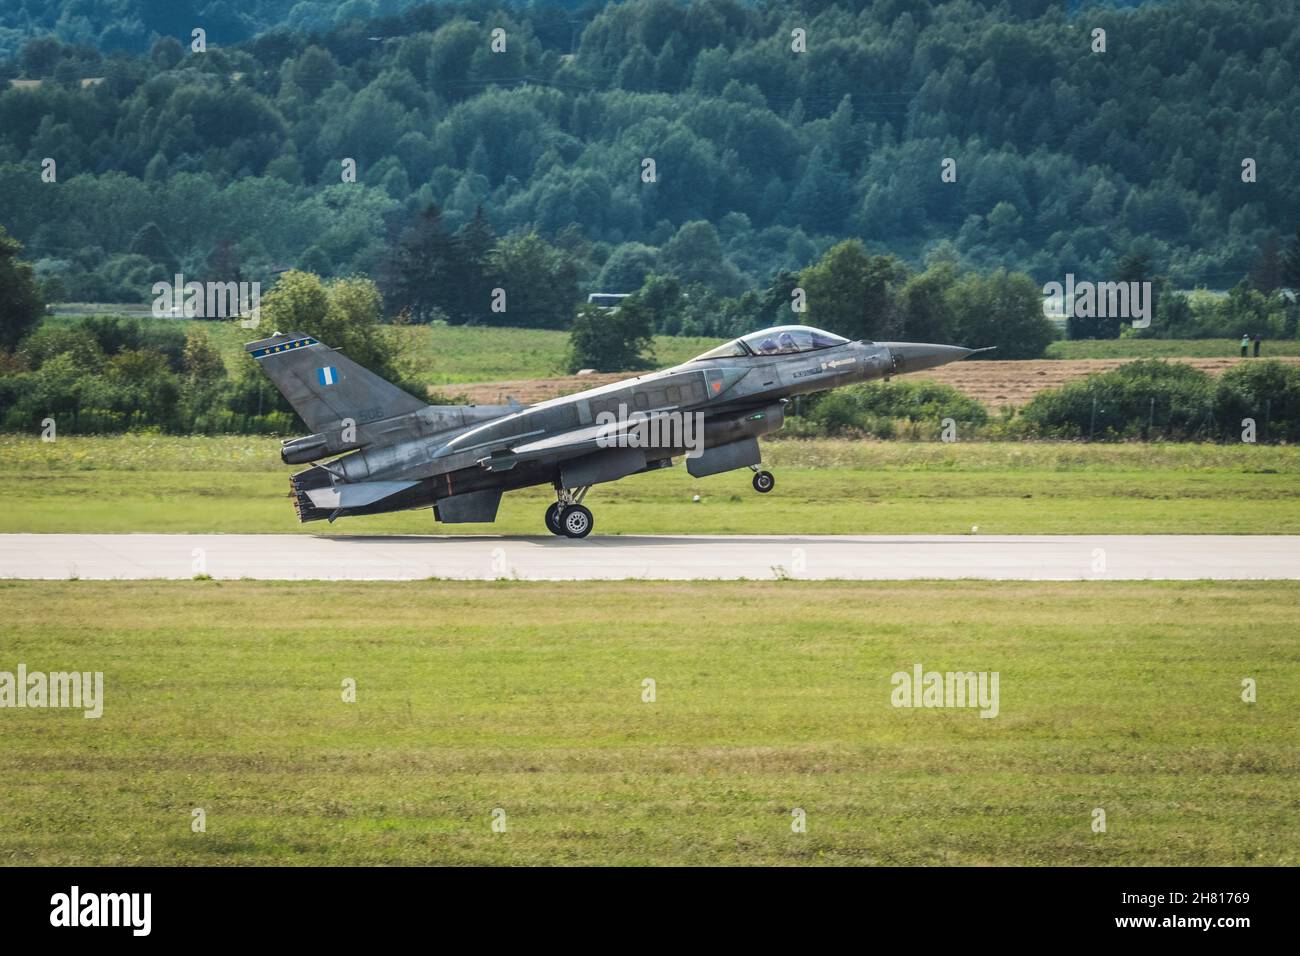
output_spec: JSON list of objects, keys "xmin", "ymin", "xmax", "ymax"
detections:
[{"xmin": 0, "ymin": 581, "xmax": 1300, "ymax": 865}]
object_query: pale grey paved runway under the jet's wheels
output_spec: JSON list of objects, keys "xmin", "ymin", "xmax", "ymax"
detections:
[{"xmin": 0, "ymin": 535, "xmax": 1300, "ymax": 580}]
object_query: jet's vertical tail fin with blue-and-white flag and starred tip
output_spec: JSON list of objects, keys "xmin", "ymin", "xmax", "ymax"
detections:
[{"xmin": 244, "ymin": 332, "xmax": 426, "ymax": 432}]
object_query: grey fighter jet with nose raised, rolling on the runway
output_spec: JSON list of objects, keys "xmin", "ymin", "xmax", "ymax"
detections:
[{"xmin": 244, "ymin": 325, "xmax": 987, "ymax": 538}]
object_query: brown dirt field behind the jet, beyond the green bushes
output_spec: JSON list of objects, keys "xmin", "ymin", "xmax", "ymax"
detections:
[{"xmin": 445, "ymin": 358, "xmax": 1300, "ymax": 408}]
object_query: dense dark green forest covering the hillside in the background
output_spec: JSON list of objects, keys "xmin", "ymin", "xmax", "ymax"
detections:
[{"xmin": 0, "ymin": 0, "xmax": 1300, "ymax": 327}]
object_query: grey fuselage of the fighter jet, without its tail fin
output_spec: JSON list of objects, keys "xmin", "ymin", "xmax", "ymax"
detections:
[{"xmin": 276, "ymin": 325, "xmax": 971, "ymax": 520}]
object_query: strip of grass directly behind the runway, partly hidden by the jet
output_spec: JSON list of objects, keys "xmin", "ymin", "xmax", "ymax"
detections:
[{"xmin": 10, "ymin": 436, "xmax": 1300, "ymax": 535}]
